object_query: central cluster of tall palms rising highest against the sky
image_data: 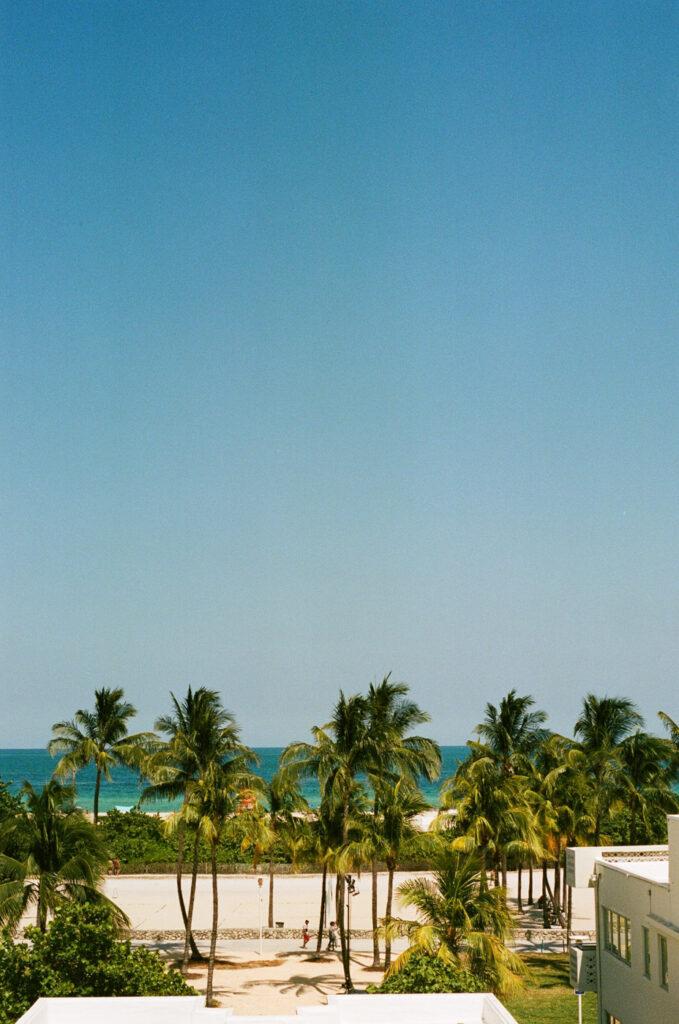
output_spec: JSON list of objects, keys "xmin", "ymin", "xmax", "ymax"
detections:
[{"xmin": 281, "ymin": 676, "xmax": 441, "ymax": 991}]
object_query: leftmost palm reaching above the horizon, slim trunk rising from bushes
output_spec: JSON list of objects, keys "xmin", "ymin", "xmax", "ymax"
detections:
[{"xmin": 47, "ymin": 686, "xmax": 155, "ymax": 824}]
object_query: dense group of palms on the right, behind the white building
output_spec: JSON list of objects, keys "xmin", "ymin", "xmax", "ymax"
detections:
[{"xmin": 441, "ymin": 690, "xmax": 679, "ymax": 926}]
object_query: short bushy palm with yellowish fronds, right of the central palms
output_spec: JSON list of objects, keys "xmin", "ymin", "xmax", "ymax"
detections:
[{"xmin": 391, "ymin": 842, "xmax": 524, "ymax": 991}]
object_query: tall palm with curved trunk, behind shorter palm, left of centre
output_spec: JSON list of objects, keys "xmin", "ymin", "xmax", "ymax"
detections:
[{"xmin": 139, "ymin": 686, "xmax": 229, "ymax": 972}]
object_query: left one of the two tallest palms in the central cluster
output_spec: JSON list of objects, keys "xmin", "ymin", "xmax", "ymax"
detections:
[{"xmin": 281, "ymin": 690, "xmax": 378, "ymax": 992}]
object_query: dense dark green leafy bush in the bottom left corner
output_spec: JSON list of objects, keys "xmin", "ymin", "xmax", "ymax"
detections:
[{"xmin": 0, "ymin": 903, "xmax": 195, "ymax": 1024}]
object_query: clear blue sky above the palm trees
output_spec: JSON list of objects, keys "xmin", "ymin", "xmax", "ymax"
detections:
[{"xmin": 0, "ymin": 0, "xmax": 679, "ymax": 746}]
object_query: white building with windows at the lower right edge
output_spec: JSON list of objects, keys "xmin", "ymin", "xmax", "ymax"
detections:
[{"xmin": 566, "ymin": 815, "xmax": 679, "ymax": 1024}]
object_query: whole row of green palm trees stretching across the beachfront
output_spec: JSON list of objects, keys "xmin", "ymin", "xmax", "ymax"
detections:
[{"xmin": 0, "ymin": 676, "xmax": 679, "ymax": 1002}]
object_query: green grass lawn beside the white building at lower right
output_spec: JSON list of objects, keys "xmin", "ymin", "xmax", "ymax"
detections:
[{"xmin": 503, "ymin": 953, "xmax": 596, "ymax": 1024}]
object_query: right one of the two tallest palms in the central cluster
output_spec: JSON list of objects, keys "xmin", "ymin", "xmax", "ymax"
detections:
[{"xmin": 368, "ymin": 673, "xmax": 441, "ymax": 968}]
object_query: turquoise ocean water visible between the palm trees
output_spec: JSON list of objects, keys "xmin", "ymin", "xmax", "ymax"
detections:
[{"xmin": 0, "ymin": 746, "xmax": 468, "ymax": 811}]
